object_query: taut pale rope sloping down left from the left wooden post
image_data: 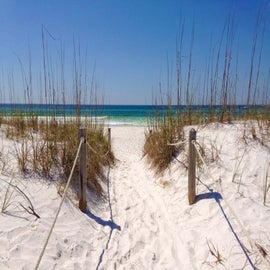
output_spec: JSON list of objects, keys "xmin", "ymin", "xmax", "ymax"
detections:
[{"xmin": 35, "ymin": 138, "xmax": 85, "ymax": 270}]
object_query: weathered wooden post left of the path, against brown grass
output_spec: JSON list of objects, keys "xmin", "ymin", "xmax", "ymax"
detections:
[{"xmin": 79, "ymin": 127, "xmax": 87, "ymax": 212}]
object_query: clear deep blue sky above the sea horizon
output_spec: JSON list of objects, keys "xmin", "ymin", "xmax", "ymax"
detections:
[{"xmin": 0, "ymin": 0, "xmax": 270, "ymax": 104}]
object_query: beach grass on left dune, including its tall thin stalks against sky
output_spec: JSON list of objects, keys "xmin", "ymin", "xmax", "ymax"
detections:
[{"xmin": 0, "ymin": 29, "xmax": 115, "ymax": 196}]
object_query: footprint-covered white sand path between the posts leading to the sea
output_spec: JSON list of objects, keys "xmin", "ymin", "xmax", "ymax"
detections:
[{"xmin": 100, "ymin": 127, "xmax": 191, "ymax": 269}]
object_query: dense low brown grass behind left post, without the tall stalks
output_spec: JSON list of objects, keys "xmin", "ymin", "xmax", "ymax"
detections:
[{"xmin": 3, "ymin": 118, "xmax": 115, "ymax": 196}]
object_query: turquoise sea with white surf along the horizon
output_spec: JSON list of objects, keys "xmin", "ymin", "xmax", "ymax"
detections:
[{"xmin": 0, "ymin": 104, "xmax": 258, "ymax": 126}]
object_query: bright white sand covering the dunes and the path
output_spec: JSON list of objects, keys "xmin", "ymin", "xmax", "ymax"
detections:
[{"xmin": 0, "ymin": 123, "xmax": 270, "ymax": 270}]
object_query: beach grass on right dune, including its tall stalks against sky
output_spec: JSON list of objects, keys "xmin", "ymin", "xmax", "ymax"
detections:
[{"xmin": 144, "ymin": 8, "xmax": 270, "ymax": 173}]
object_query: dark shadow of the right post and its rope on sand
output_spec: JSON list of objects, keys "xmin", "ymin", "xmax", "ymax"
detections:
[{"xmin": 195, "ymin": 178, "xmax": 257, "ymax": 270}]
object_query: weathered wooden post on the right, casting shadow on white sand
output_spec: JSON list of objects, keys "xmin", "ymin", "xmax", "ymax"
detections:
[{"xmin": 188, "ymin": 128, "xmax": 196, "ymax": 204}]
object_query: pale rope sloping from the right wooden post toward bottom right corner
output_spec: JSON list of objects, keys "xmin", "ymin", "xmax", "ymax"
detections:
[{"xmin": 190, "ymin": 130, "xmax": 270, "ymax": 269}]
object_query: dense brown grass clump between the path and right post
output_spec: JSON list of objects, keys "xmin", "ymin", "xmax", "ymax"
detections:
[{"xmin": 144, "ymin": 109, "xmax": 184, "ymax": 174}]
